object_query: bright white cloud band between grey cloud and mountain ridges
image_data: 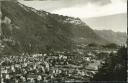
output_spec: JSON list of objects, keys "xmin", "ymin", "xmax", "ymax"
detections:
[{"xmin": 52, "ymin": 0, "xmax": 127, "ymax": 18}]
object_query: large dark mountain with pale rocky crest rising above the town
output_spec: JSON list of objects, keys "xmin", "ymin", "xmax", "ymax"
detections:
[{"xmin": 1, "ymin": 1, "xmax": 107, "ymax": 53}]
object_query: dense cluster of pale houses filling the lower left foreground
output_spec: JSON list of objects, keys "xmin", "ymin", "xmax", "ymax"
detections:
[{"xmin": 0, "ymin": 54, "xmax": 97, "ymax": 83}]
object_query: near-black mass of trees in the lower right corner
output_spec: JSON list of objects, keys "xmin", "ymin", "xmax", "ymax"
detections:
[{"xmin": 91, "ymin": 47, "xmax": 127, "ymax": 82}]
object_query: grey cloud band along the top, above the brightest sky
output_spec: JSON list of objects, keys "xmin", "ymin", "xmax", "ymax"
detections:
[{"xmin": 19, "ymin": 0, "xmax": 111, "ymax": 12}]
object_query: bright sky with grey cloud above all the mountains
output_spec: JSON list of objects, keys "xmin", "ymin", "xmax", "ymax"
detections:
[{"xmin": 20, "ymin": 0, "xmax": 127, "ymax": 31}]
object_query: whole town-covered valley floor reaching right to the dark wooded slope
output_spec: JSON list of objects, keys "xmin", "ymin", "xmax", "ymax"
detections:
[{"xmin": 0, "ymin": 46, "xmax": 116, "ymax": 83}]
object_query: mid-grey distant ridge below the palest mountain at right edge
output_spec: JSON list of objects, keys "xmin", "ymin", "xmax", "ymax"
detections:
[{"xmin": 95, "ymin": 30, "xmax": 127, "ymax": 45}]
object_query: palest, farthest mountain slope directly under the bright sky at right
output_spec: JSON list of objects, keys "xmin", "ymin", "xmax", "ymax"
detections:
[{"xmin": 82, "ymin": 13, "xmax": 127, "ymax": 32}]
